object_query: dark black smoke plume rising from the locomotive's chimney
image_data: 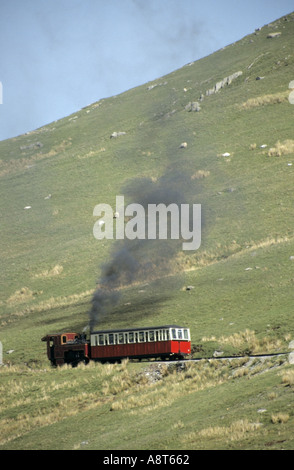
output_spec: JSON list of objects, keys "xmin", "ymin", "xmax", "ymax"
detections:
[{"xmin": 89, "ymin": 163, "xmax": 195, "ymax": 331}]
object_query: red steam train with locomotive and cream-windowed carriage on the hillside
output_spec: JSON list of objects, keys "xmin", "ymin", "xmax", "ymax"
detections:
[{"xmin": 42, "ymin": 325, "xmax": 191, "ymax": 366}]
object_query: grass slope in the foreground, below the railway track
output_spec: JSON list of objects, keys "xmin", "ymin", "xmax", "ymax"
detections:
[{"xmin": 1, "ymin": 359, "xmax": 293, "ymax": 450}]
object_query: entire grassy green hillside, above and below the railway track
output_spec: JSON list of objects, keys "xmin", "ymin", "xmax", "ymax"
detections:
[{"xmin": 0, "ymin": 14, "xmax": 294, "ymax": 449}]
